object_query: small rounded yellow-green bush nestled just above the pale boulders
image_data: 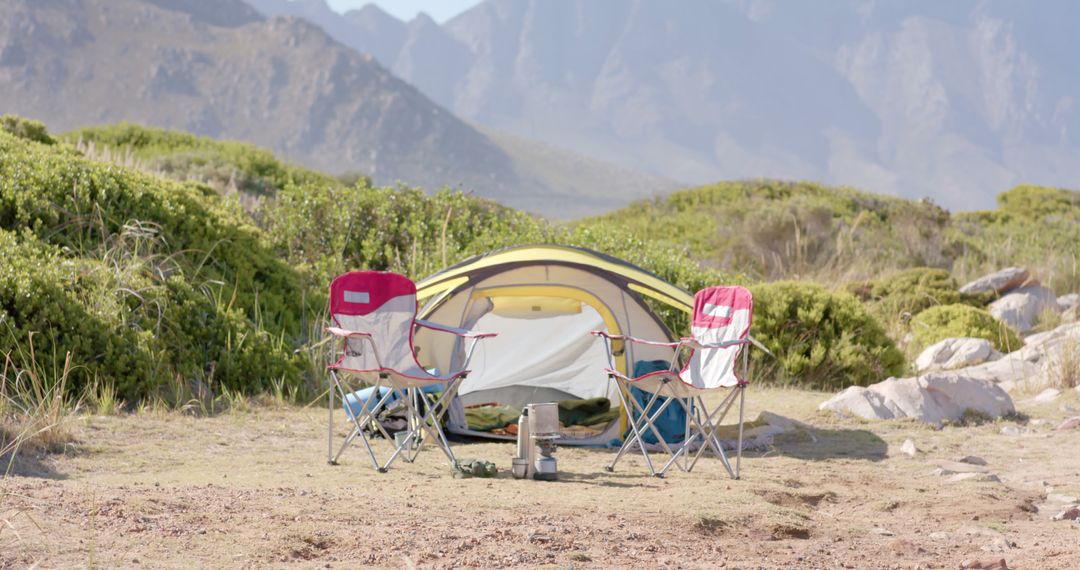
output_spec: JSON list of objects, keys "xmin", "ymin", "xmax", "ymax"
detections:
[{"xmin": 912, "ymin": 304, "xmax": 1024, "ymax": 352}]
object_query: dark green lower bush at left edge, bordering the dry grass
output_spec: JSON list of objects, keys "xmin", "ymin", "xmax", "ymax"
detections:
[{"xmin": 0, "ymin": 230, "xmax": 300, "ymax": 402}]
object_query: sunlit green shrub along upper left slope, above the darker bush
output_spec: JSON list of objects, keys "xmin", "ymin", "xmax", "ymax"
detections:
[{"xmin": 0, "ymin": 128, "xmax": 303, "ymax": 335}]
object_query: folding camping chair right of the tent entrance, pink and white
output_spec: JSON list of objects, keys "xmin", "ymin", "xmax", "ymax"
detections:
[{"xmin": 593, "ymin": 287, "xmax": 754, "ymax": 479}]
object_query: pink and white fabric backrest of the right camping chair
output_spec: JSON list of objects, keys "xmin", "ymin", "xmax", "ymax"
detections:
[{"xmin": 679, "ymin": 286, "xmax": 754, "ymax": 389}]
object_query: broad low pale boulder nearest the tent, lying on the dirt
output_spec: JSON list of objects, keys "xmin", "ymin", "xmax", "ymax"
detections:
[{"xmin": 819, "ymin": 372, "xmax": 1014, "ymax": 424}]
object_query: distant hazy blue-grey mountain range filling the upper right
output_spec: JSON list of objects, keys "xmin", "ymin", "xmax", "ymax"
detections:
[{"xmin": 251, "ymin": 0, "xmax": 1080, "ymax": 209}]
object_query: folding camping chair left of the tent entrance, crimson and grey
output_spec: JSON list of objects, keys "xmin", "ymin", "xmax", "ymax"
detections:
[{"xmin": 326, "ymin": 271, "xmax": 495, "ymax": 473}]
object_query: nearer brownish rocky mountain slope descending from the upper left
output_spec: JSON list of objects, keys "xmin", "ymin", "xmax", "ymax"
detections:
[{"xmin": 0, "ymin": 0, "xmax": 671, "ymax": 217}]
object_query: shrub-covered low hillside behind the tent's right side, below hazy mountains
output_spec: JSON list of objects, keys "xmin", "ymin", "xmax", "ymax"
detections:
[{"xmin": 586, "ymin": 180, "xmax": 1080, "ymax": 291}]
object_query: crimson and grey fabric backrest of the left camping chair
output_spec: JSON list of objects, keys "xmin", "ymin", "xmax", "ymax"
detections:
[{"xmin": 330, "ymin": 271, "xmax": 420, "ymax": 375}]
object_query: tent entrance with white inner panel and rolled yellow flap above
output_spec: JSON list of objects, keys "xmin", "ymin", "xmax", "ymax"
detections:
[{"xmin": 459, "ymin": 285, "xmax": 621, "ymax": 438}]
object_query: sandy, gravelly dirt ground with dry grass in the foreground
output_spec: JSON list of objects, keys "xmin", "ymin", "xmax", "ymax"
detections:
[{"xmin": 0, "ymin": 389, "xmax": 1080, "ymax": 569}]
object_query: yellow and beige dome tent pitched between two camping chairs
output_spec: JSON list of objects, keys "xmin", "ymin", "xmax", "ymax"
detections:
[{"xmin": 414, "ymin": 245, "xmax": 693, "ymax": 445}]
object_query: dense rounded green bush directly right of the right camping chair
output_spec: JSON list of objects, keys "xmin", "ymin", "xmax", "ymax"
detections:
[{"xmin": 751, "ymin": 282, "xmax": 906, "ymax": 391}]
